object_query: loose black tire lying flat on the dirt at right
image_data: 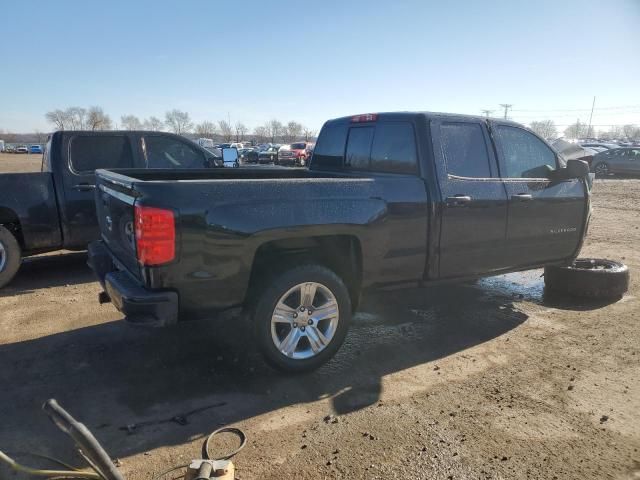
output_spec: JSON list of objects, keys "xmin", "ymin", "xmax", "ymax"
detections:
[{"xmin": 544, "ymin": 258, "xmax": 629, "ymax": 300}]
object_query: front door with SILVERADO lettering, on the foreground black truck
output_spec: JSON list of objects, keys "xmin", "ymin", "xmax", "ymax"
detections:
[{"xmin": 492, "ymin": 123, "xmax": 587, "ymax": 268}]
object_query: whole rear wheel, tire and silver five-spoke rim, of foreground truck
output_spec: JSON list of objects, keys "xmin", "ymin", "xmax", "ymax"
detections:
[{"xmin": 253, "ymin": 265, "xmax": 351, "ymax": 373}]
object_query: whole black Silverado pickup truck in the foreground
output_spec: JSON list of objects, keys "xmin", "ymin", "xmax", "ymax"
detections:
[{"xmin": 89, "ymin": 113, "xmax": 590, "ymax": 371}]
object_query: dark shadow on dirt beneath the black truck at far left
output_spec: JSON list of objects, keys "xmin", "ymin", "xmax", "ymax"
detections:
[{"xmin": 0, "ymin": 252, "xmax": 95, "ymax": 298}]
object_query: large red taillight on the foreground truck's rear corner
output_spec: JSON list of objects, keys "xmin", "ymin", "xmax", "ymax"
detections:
[{"xmin": 135, "ymin": 205, "xmax": 176, "ymax": 265}]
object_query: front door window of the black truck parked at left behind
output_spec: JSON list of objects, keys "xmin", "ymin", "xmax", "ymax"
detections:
[{"xmin": 144, "ymin": 136, "xmax": 206, "ymax": 168}]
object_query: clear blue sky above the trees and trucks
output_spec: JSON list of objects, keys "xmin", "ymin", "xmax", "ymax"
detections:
[{"xmin": 0, "ymin": 0, "xmax": 640, "ymax": 132}]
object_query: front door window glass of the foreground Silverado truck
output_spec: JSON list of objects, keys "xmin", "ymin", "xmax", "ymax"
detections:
[{"xmin": 496, "ymin": 125, "xmax": 557, "ymax": 178}]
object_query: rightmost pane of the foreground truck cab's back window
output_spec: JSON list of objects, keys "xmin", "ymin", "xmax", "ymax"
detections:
[{"xmin": 371, "ymin": 122, "xmax": 418, "ymax": 173}]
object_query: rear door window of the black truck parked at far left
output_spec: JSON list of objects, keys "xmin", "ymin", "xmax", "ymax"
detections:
[{"xmin": 69, "ymin": 135, "xmax": 133, "ymax": 173}]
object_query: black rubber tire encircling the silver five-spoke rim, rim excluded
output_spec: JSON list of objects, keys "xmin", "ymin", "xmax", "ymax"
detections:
[{"xmin": 251, "ymin": 264, "xmax": 351, "ymax": 373}]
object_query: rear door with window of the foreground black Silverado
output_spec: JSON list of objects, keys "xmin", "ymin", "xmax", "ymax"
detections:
[{"xmin": 431, "ymin": 120, "xmax": 507, "ymax": 278}]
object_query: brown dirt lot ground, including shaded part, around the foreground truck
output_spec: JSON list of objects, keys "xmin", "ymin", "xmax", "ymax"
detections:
[{"xmin": 0, "ymin": 176, "xmax": 640, "ymax": 480}]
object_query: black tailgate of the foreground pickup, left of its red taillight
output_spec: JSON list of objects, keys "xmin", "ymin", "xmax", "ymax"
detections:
[{"xmin": 96, "ymin": 171, "xmax": 141, "ymax": 278}]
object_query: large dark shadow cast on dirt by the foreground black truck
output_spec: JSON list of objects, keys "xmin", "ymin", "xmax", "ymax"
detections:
[{"xmin": 0, "ymin": 270, "xmax": 616, "ymax": 473}]
